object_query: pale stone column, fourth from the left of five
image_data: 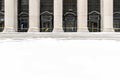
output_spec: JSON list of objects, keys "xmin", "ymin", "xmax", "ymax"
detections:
[{"xmin": 77, "ymin": 0, "xmax": 88, "ymax": 32}]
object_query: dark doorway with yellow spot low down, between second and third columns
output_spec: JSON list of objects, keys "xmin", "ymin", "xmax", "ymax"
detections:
[{"xmin": 40, "ymin": 0, "xmax": 54, "ymax": 32}]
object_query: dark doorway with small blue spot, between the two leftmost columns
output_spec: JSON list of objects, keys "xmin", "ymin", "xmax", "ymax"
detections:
[{"xmin": 17, "ymin": 0, "xmax": 29, "ymax": 32}]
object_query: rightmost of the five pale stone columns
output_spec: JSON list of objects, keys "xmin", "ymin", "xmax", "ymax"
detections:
[{"xmin": 101, "ymin": 0, "xmax": 114, "ymax": 32}]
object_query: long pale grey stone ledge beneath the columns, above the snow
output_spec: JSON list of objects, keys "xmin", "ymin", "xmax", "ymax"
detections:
[{"xmin": 0, "ymin": 32, "xmax": 120, "ymax": 40}]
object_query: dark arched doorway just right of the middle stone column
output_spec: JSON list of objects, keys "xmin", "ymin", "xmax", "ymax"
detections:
[{"xmin": 63, "ymin": 0, "xmax": 77, "ymax": 32}]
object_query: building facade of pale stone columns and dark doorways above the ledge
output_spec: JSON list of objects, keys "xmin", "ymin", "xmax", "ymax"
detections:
[{"xmin": 0, "ymin": 0, "xmax": 120, "ymax": 32}]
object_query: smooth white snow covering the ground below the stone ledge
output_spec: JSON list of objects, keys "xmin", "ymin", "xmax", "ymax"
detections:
[{"xmin": 0, "ymin": 38, "xmax": 120, "ymax": 80}]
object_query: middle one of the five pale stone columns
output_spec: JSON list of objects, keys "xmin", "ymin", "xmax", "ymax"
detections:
[{"xmin": 53, "ymin": 0, "xmax": 63, "ymax": 32}]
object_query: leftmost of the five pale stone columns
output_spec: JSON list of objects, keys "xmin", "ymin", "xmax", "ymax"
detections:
[{"xmin": 4, "ymin": 0, "xmax": 17, "ymax": 32}]
